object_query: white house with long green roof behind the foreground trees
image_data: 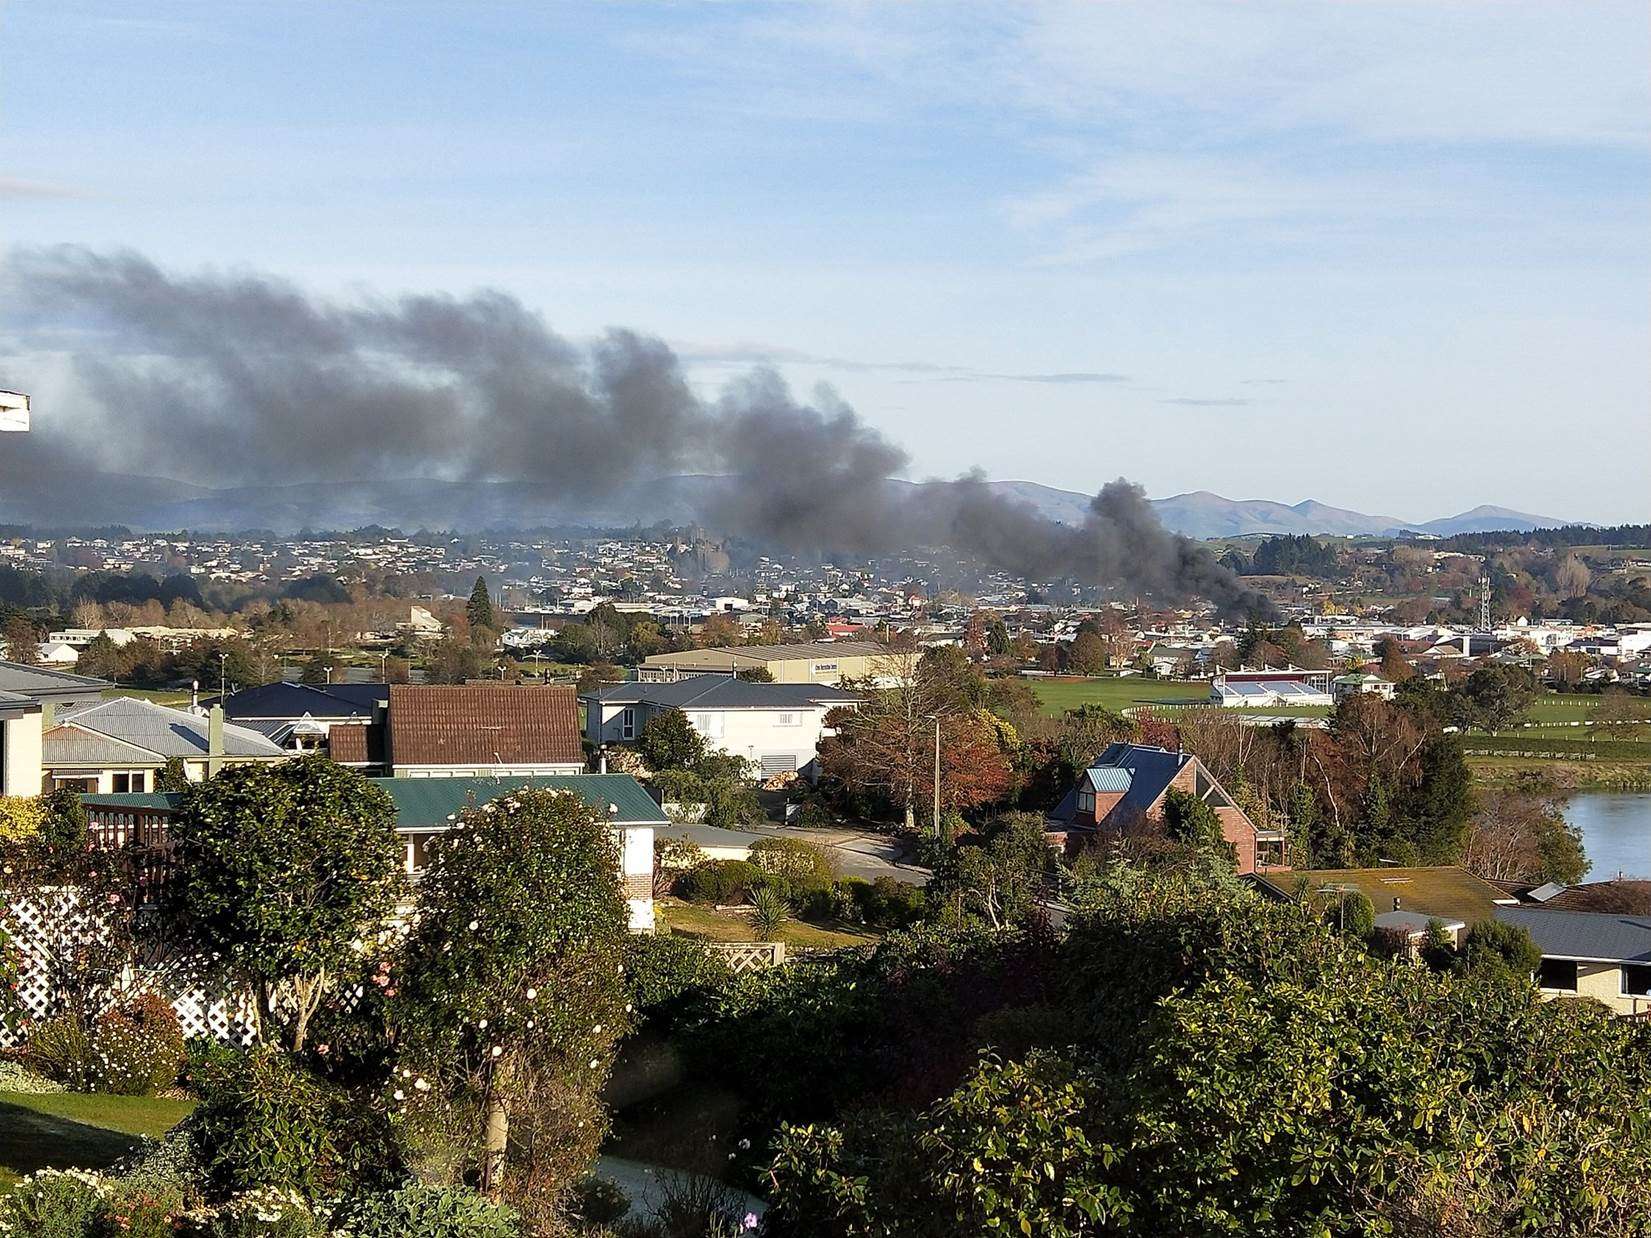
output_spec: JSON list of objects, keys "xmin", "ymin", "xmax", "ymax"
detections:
[{"xmin": 81, "ymin": 774, "xmax": 669, "ymax": 933}]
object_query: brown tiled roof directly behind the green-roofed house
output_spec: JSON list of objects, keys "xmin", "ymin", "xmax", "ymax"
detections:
[{"xmin": 388, "ymin": 683, "xmax": 584, "ymax": 766}]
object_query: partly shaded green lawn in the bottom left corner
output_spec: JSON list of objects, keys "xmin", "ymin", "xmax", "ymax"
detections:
[{"xmin": 0, "ymin": 1091, "xmax": 195, "ymax": 1187}]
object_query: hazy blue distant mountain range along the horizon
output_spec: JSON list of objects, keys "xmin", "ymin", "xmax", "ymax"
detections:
[{"xmin": 0, "ymin": 472, "xmax": 1573, "ymax": 538}]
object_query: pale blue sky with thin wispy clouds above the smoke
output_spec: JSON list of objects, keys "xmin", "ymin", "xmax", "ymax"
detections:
[{"xmin": 0, "ymin": 0, "xmax": 1651, "ymax": 522}]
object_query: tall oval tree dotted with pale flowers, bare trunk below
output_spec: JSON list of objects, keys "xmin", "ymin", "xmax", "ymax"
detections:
[{"xmin": 395, "ymin": 787, "xmax": 627, "ymax": 1212}]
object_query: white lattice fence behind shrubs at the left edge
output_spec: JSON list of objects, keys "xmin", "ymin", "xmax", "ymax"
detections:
[{"xmin": 0, "ymin": 888, "xmax": 253, "ymax": 1048}]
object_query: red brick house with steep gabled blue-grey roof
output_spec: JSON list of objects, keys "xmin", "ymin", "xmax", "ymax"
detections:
[{"xmin": 1048, "ymin": 743, "xmax": 1284, "ymax": 873}]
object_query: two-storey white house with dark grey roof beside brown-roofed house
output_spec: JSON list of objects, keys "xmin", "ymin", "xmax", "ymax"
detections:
[{"xmin": 580, "ymin": 672, "xmax": 860, "ymax": 777}]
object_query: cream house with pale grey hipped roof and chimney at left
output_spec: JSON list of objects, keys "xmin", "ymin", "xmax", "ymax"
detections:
[{"xmin": 36, "ymin": 697, "xmax": 291, "ymax": 792}]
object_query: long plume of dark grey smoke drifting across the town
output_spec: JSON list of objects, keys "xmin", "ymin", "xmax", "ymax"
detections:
[{"xmin": 0, "ymin": 248, "xmax": 1265, "ymax": 612}]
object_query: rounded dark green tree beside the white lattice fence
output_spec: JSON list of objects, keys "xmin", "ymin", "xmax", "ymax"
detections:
[{"xmin": 165, "ymin": 756, "xmax": 404, "ymax": 1050}]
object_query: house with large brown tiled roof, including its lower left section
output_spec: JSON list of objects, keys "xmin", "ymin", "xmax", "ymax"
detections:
[{"xmin": 327, "ymin": 683, "xmax": 584, "ymax": 777}]
